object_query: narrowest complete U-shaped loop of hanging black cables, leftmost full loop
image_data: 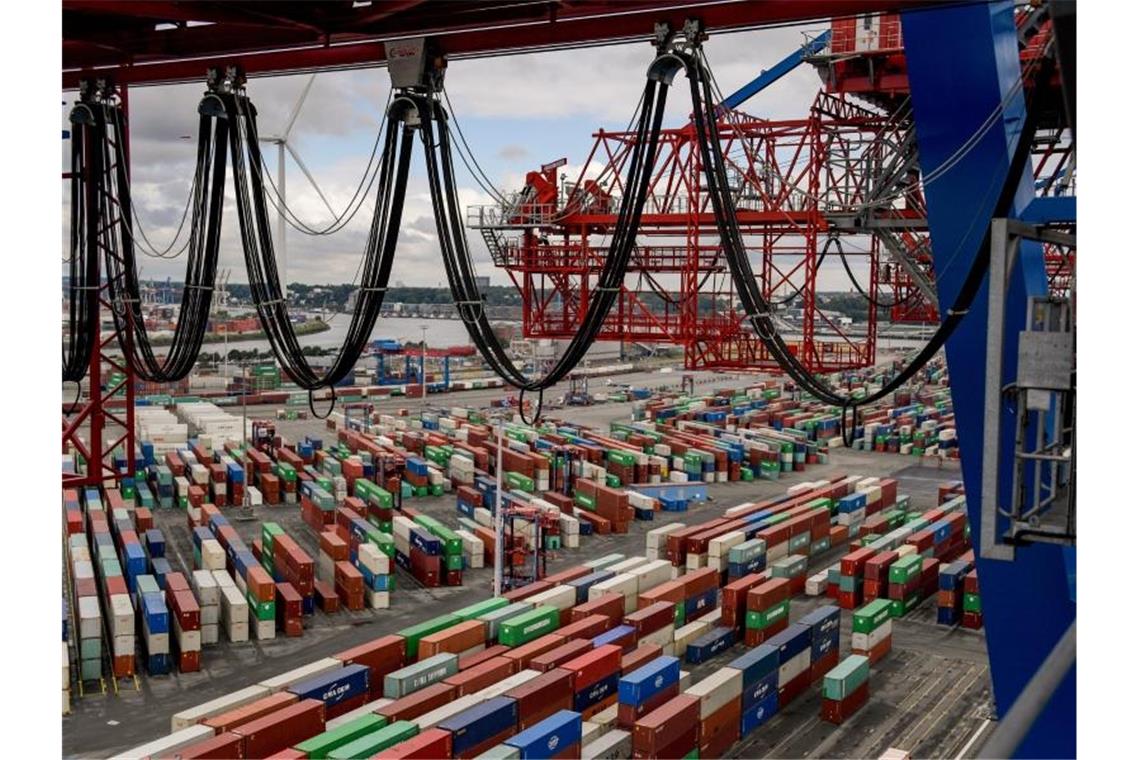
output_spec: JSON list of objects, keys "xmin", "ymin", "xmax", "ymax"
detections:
[{"xmin": 97, "ymin": 93, "xmax": 229, "ymax": 383}]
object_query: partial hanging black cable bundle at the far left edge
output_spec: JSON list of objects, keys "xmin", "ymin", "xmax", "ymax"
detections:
[{"xmin": 63, "ymin": 90, "xmax": 103, "ymax": 384}]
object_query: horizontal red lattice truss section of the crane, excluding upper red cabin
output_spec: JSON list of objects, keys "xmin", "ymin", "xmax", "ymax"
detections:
[{"xmin": 469, "ymin": 92, "xmax": 925, "ymax": 373}]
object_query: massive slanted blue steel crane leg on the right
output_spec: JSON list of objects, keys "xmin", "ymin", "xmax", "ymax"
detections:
[{"xmin": 902, "ymin": 1, "xmax": 1076, "ymax": 758}]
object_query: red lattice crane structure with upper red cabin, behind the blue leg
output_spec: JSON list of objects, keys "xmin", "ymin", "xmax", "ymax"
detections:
[{"xmin": 467, "ymin": 5, "xmax": 1072, "ymax": 373}]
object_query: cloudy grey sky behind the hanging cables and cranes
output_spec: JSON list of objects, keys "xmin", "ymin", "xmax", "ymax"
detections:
[{"xmin": 62, "ymin": 23, "xmax": 875, "ymax": 289}]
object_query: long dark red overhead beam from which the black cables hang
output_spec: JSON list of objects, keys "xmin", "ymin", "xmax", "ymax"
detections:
[{"xmin": 63, "ymin": 0, "xmax": 929, "ymax": 89}]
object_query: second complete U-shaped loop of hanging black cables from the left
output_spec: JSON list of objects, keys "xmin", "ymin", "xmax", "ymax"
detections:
[{"xmin": 225, "ymin": 88, "xmax": 415, "ymax": 391}]
